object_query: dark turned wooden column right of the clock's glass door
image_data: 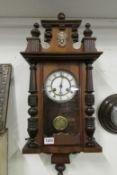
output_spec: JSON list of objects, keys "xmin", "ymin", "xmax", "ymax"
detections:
[{"xmin": 85, "ymin": 63, "xmax": 95, "ymax": 147}]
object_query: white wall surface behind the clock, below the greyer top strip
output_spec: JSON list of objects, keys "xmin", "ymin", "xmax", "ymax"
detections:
[{"xmin": 0, "ymin": 18, "xmax": 117, "ymax": 175}]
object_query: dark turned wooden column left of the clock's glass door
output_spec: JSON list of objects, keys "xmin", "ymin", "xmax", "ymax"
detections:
[{"xmin": 27, "ymin": 64, "xmax": 38, "ymax": 148}]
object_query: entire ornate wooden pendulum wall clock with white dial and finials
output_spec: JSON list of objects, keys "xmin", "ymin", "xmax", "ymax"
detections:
[{"xmin": 21, "ymin": 13, "xmax": 102, "ymax": 175}]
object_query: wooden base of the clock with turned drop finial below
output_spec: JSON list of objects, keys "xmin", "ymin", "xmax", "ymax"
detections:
[{"xmin": 23, "ymin": 143, "xmax": 102, "ymax": 175}]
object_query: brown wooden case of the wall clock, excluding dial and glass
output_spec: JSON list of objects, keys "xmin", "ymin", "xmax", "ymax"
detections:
[{"xmin": 21, "ymin": 13, "xmax": 102, "ymax": 175}]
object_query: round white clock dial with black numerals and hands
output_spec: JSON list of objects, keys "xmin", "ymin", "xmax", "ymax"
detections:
[{"xmin": 44, "ymin": 70, "xmax": 78, "ymax": 103}]
